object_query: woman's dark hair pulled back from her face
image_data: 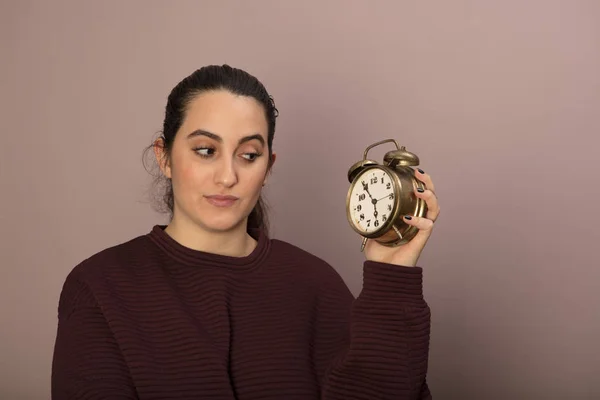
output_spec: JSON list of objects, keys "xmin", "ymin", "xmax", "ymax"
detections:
[{"xmin": 147, "ymin": 65, "xmax": 279, "ymax": 234}]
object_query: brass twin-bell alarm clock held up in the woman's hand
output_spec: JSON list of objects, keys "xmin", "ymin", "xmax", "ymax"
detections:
[{"xmin": 346, "ymin": 139, "xmax": 427, "ymax": 251}]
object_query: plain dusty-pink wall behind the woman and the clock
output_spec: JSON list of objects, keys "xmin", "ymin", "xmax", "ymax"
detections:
[{"xmin": 0, "ymin": 0, "xmax": 600, "ymax": 400}]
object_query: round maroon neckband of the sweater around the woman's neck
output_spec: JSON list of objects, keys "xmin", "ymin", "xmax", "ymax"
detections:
[{"xmin": 147, "ymin": 225, "xmax": 271, "ymax": 271}]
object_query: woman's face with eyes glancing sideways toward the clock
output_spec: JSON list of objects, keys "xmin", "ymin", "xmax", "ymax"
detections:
[{"xmin": 157, "ymin": 90, "xmax": 275, "ymax": 232}]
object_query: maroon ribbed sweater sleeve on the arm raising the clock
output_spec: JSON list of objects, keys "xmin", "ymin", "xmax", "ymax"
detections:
[{"xmin": 315, "ymin": 261, "xmax": 431, "ymax": 400}]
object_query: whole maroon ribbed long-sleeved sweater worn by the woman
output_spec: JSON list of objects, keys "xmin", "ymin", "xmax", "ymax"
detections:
[{"xmin": 52, "ymin": 226, "xmax": 431, "ymax": 400}]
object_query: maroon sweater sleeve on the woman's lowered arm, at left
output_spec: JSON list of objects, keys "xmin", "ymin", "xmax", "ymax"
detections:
[{"xmin": 51, "ymin": 274, "xmax": 137, "ymax": 400}]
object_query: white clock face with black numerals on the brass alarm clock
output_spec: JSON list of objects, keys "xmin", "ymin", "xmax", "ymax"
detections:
[{"xmin": 348, "ymin": 168, "xmax": 395, "ymax": 233}]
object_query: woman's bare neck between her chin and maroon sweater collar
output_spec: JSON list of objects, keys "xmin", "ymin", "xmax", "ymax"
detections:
[{"xmin": 165, "ymin": 217, "xmax": 256, "ymax": 257}]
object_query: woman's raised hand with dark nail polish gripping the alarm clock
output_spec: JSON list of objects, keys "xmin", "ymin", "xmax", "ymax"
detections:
[{"xmin": 364, "ymin": 170, "xmax": 440, "ymax": 267}]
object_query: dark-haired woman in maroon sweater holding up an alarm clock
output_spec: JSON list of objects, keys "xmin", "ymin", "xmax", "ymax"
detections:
[{"xmin": 52, "ymin": 65, "xmax": 439, "ymax": 400}]
